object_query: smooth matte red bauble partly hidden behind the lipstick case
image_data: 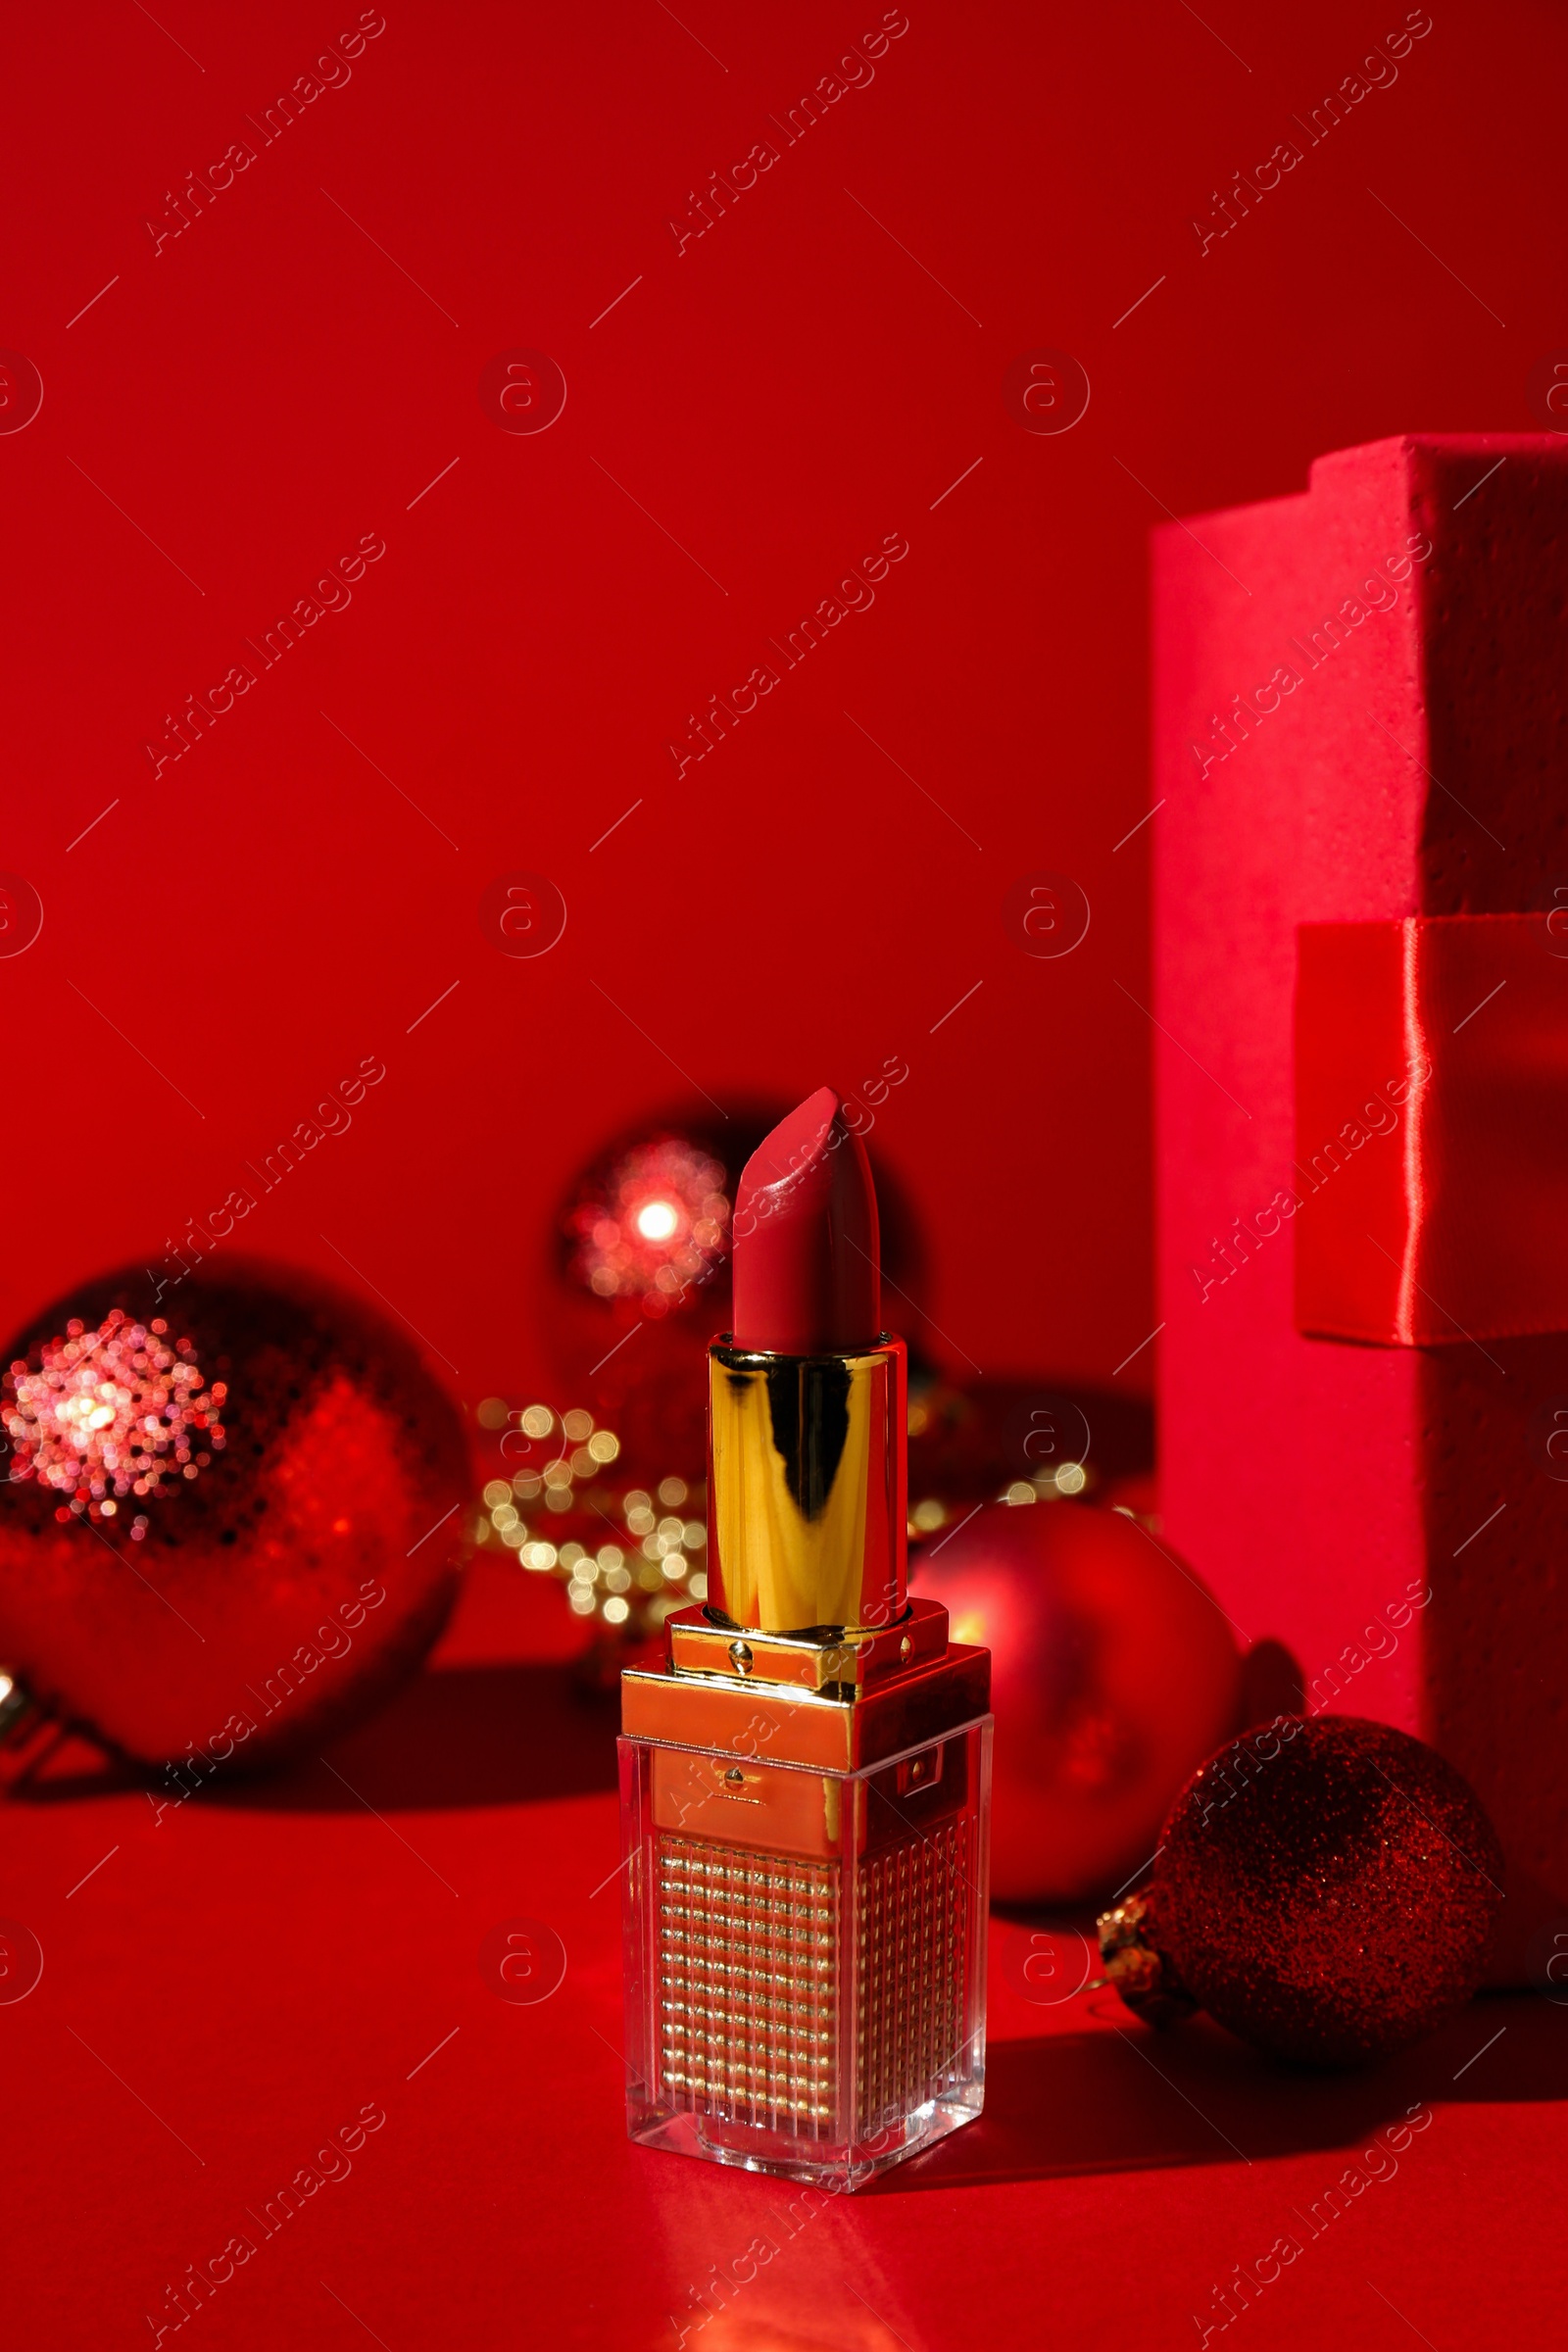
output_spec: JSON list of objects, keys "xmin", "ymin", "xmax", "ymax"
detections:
[{"xmin": 914, "ymin": 1503, "xmax": 1239, "ymax": 1903}]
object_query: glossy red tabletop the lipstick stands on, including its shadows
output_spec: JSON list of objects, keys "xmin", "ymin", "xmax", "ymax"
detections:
[{"xmin": 0, "ymin": 1569, "xmax": 1568, "ymax": 2352}]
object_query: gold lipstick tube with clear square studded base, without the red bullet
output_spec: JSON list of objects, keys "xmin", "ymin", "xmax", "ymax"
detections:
[{"xmin": 620, "ymin": 1339, "xmax": 992, "ymax": 2187}]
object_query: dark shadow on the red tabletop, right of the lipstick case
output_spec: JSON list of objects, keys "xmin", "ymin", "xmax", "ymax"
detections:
[{"xmin": 883, "ymin": 1992, "xmax": 1568, "ymax": 2197}]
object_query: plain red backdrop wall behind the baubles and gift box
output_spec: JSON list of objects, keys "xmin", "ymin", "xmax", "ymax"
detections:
[{"xmin": 0, "ymin": 0, "xmax": 1566, "ymax": 1399}]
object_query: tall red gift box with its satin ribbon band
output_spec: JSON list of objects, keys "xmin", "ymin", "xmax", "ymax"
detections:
[{"xmin": 1154, "ymin": 435, "xmax": 1568, "ymax": 1983}]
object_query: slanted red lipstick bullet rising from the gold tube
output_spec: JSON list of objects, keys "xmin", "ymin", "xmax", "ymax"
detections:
[{"xmin": 731, "ymin": 1087, "xmax": 882, "ymax": 1354}]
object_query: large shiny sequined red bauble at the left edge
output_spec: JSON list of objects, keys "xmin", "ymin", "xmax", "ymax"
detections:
[{"xmin": 0, "ymin": 1263, "xmax": 470, "ymax": 1769}]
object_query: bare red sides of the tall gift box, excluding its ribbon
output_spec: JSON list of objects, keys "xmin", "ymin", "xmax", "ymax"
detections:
[{"xmin": 1156, "ymin": 437, "xmax": 1568, "ymax": 1981}]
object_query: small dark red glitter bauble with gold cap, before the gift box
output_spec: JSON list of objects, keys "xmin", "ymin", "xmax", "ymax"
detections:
[{"xmin": 1101, "ymin": 1715, "xmax": 1502, "ymax": 2065}]
